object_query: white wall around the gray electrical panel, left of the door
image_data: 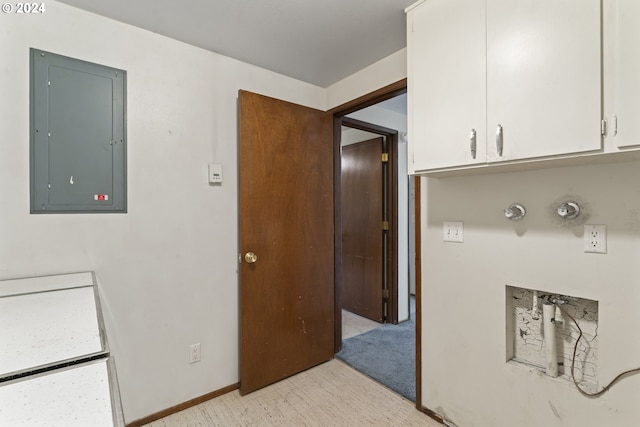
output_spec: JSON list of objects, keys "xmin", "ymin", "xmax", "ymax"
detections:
[{"xmin": 0, "ymin": 1, "xmax": 326, "ymax": 422}]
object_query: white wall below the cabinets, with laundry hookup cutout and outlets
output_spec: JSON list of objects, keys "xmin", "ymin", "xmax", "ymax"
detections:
[{"xmin": 422, "ymin": 163, "xmax": 640, "ymax": 427}]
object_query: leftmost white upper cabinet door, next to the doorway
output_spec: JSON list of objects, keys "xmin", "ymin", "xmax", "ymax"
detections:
[{"xmin": 407, "ymin": 0, "xmax": 486, "ymax": 172}]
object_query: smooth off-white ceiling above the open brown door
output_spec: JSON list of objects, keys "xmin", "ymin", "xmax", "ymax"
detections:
[{"xmin": 53, "ymin": 0, "xmax": 416, "ymax": 87}]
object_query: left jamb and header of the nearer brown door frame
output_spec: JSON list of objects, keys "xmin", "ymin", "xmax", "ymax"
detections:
[{"xmin": 329, "ymin": 78, "xmax": 408, "ymax": 350}]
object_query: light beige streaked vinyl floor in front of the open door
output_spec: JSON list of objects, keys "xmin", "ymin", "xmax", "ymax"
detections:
[{"xmin": 147, "ymin": 359, "xmax": 441, "ymax": 427}]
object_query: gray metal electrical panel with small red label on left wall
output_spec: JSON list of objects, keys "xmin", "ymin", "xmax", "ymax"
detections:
[{"xmin": 30, "ymin": 49, "xmax": 127, "ymax": 213}]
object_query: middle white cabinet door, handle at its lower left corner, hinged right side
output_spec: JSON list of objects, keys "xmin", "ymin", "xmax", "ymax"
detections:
[{"xmin": 487, "ymin": 0, "xmax": 604, "ymax": 162}]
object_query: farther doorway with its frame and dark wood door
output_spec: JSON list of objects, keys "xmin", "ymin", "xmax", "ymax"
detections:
[{"xmin": 337, "ymin": 117, "xmax": 406, "ymax": 324}]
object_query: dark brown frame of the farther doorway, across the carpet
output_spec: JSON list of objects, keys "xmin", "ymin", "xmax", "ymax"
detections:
[{"xmin": 334, "ymin": 117, "xmax": 398, "ymax": 325}]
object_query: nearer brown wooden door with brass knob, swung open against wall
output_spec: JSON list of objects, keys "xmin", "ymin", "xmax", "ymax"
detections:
[{"xmin": 238, "ymin": 91, "xmax": 334, "ymax": 394}]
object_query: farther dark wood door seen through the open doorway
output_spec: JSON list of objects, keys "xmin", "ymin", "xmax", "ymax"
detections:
[{"xmin": 341, "ymin": 138, "xmax": 384, "ymax": 322}]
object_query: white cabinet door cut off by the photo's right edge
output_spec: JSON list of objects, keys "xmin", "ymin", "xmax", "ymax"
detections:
[{"xmin": 605, "ymin": 0, "xmax": 640, "ymax": 147}]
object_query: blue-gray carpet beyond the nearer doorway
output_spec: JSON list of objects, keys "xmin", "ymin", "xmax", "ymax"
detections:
[{"xmin": 336, "ymin": 313, "xmax": 416, "ymax": 402}]
